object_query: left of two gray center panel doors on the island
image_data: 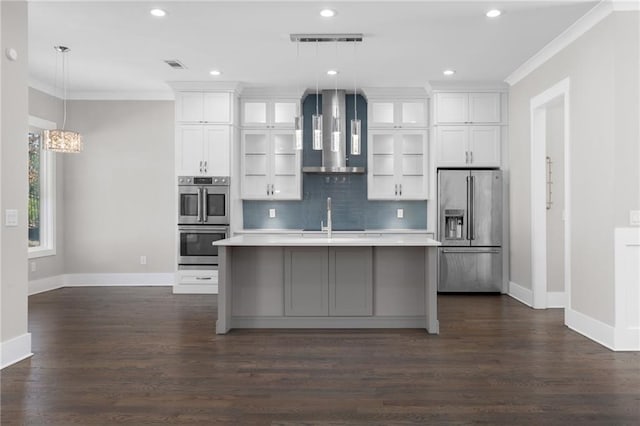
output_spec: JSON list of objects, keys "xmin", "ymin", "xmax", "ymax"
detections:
[{"xmin": 284, "ymin": 247, "xmax": 329, "ymax": 316}]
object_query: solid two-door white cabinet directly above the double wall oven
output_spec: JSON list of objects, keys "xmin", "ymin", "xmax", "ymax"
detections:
[{"xmin": 176, "ymin": 124, "xmax": 231, "ymax": 176}]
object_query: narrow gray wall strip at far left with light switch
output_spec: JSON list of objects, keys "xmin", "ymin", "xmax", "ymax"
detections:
[{"xmin": 0, "ymin": 1, "xmax": 28, "ymax": 343}]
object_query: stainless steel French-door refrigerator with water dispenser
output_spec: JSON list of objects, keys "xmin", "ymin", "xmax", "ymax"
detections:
[{"xmin": 438, "ymin": 169, "xmax": 502, "ymax": 292}]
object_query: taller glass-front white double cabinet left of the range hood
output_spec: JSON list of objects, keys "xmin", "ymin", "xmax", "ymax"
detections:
[{"xmin": 240, "ymin": 129, "xmax": 302, "ymax": 200}]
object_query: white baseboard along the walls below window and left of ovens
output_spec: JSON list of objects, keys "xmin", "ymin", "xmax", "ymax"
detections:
[{"xmin": 29, "ymin": 272, "xmax": 175, "ymax": 296}]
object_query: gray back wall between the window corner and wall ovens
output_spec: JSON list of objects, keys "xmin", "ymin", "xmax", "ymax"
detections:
[{"xmin": 63, "ymin": 101, "xmax": 176, "ymax": 273}]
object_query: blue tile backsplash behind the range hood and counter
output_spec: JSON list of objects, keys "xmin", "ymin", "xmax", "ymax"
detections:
[{"xmin": 243, "ymin": 95, "xmax": 427, "ymax": 231}]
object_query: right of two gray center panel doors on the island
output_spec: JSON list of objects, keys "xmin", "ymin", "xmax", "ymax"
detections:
[{"xmin": 329, "ymin": 247, "xmax": 373, "ymax": 316}]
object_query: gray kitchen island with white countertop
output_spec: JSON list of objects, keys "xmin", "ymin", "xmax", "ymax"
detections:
[{"xmin": 214, "ymin": 233, "xmax": 440, "ymax": 334}]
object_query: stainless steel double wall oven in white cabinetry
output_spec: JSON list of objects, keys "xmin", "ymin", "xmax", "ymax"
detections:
[{"xmin": 178, "ymin": 176, "xmax": 229, "ymax": 269}]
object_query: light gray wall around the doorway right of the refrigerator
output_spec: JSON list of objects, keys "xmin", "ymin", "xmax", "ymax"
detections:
[{"xmin": 509, "ymin": 12, "xmax": 640, "ymax": 325}]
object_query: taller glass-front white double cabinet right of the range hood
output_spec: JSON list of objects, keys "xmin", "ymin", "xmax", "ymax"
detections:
[{"xmin": 367, "ymin": 130, "xmax": 429, "ymax": 200}]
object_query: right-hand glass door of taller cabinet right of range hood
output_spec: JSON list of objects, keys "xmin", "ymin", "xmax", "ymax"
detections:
[{"xmin": 397, "ymin": 131, "xmax": 429, "ymax": 200}]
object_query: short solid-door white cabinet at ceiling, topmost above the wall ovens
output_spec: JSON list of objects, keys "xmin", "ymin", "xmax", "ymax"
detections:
[{"xmin": 176, "ymin": 92, "xmax": 232, "ymax": 124}]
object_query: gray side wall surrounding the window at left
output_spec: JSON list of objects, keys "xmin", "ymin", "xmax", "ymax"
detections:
[{"xmin": 29, "ymin": 88, "xmax": 69, "ymax": 280}]
